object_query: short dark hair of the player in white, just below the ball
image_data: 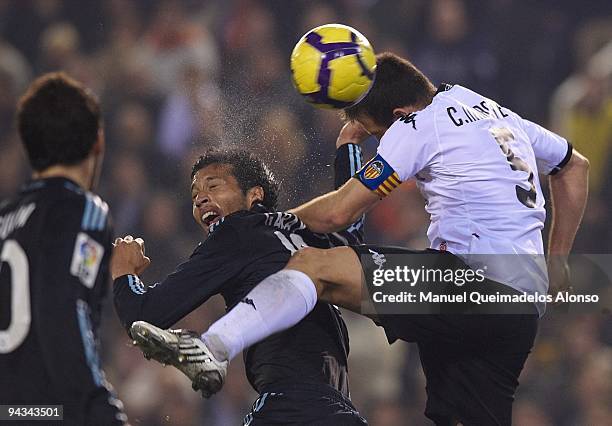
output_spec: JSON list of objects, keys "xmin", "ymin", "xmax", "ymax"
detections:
[{"xmin": 342, "ymin": 52, "xmax": 435, "ymax": 127}]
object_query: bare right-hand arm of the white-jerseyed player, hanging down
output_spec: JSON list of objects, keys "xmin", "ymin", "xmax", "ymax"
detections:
[{"xmin": 548, "ymin": 150, "xmax": 589, "ymax": 293}]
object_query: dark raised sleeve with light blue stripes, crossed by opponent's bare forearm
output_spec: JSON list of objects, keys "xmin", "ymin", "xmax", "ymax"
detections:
[{"xmin": 334, "ymin": 143, "xmax": 365, "ymax": 244}]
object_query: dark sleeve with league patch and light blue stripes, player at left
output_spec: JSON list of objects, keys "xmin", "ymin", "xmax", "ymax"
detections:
[{"xmin": 38, "ymin": 194, "xmax": 127, "ymax": 425}]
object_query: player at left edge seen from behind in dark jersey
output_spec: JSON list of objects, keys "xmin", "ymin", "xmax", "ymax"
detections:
[{"xmin": 0, "ymin": 73, "xmax": 126, "ymax": 425}]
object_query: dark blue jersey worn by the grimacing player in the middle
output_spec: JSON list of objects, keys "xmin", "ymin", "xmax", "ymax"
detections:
[{"xmin": 114, "ymin": 145, "xmax": 363, "ymax": 396}]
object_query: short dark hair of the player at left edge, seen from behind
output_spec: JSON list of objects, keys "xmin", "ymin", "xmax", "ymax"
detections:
[{"xmin": 17, "ymin": 72, "xmax": 102, "ymax": 171}]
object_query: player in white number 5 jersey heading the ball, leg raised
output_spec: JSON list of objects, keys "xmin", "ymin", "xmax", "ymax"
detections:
[{"xmin": 129, "ymin": 54, "xmax": 588, "ymax": 426}]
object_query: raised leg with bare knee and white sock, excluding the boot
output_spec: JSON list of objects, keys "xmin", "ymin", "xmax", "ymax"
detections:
[{"xmin": 202, "ymin": 247, "xmax": 370, "ymax": 360}]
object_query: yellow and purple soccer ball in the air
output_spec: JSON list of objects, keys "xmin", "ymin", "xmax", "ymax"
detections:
[{"xmin": 291, "ymin": 24, "xmax": 376, "ymax": 108}]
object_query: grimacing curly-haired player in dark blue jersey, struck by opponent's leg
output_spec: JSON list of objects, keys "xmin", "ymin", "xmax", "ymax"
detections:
[{"xmin": 112, "ymin": 144, "xmax": 366, "ymax": 425}]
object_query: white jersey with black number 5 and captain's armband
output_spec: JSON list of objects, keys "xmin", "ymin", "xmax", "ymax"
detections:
[{"xmin": 361, "ymin": 85, "xmax": 571, "ymax": 313}]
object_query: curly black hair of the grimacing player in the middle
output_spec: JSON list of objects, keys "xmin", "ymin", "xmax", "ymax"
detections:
[{"xmin": 191, "ymin": 148, "xmax": 279, "ymax": 209}]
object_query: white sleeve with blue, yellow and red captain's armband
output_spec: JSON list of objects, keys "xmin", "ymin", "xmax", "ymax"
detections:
[{"xmin": 356, "ymin": 113, "xmax": 438, "ymax": 198}]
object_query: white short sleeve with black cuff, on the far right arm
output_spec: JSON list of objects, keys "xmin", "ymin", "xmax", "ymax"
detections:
[{"xmin": 521, "ymin": 119, "xmax": 573, "ymax": 175}]
